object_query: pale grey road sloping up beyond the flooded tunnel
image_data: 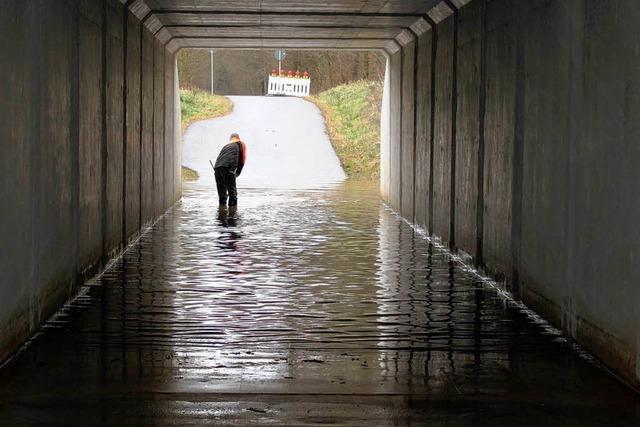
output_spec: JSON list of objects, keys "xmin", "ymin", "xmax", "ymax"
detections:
[{"xmin": 182, "ymin": 96, "xmax": 346, "ymax": 189}]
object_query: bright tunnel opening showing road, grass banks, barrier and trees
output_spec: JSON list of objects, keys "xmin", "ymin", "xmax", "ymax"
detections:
[{"xmin": 177, "ymin": 49, "xmax": 386, "ymax": 193}]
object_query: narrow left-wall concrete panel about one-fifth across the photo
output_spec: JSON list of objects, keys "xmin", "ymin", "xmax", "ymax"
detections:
[{"xmin": 125, "ymin": 13, "xmax": 141, "ymax": 238}]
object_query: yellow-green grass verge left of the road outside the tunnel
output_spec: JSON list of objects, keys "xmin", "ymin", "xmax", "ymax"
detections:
[{"xmin": 180, "ymin": 89, "xmax": 233, "ymax": 181}]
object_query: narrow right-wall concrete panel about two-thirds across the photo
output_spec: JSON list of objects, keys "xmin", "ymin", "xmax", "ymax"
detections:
[{"xmin": 414, "ymin": 31, "xmax": 433, "ymax": 229}]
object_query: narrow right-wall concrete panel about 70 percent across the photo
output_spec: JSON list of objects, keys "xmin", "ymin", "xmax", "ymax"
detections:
[{"xmin": 433, "ymin": 15, "xmax": 455, "ymax": 243}]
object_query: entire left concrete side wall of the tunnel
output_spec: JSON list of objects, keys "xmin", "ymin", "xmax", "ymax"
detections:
[{"xmin": 0, "ymin": 0, "xmax": 180, "ymax": 361}]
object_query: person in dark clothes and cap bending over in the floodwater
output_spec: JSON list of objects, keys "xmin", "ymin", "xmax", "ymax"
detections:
[{"xmin": 213, "ymin": 133, "xmax": 247, "ymax": 208}]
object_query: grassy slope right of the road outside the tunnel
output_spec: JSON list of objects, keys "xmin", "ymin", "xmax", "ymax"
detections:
[{"xmin": 310, "ymin": 80, "xmax": 382, "ymax": 180}]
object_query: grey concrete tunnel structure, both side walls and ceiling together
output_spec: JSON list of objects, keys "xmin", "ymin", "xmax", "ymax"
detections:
[{"xmin": 0, "ymin": 0, "xmax": 640, "ymax": 387}]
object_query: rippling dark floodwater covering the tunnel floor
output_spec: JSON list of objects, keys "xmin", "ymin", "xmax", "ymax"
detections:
[{"xmin": 0, "ymin": 181, "xmax": 640, "ymax": 426}]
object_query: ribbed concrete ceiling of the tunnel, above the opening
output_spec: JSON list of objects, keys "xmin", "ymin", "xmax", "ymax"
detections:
[{"xmin": 121, "ymin": 0, "xmax": 469, "ymax": 53}]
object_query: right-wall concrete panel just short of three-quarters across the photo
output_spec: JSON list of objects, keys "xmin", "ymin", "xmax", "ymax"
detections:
[{"xmin": 454, "ymin": 1, "xmax": 482, "ymax": 256}]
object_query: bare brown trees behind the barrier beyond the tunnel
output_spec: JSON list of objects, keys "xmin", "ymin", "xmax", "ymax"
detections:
[{"xmin": 178, "ymin": 49, "xmax": 385, "ymax": 95}]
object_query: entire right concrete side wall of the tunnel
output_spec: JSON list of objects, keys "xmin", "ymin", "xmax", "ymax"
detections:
[{"xmin": 383, "ymin": 0, "xmax": 640, "ymax": 386}]
